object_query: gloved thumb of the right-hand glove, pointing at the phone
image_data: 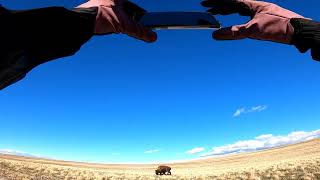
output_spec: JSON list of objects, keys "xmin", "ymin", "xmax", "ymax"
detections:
[{"xmin": 212, "ymin": 24, "xmax": 249, "ymax": 40}]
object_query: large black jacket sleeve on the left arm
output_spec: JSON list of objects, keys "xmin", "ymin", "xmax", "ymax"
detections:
[{"xmin": 0, "ymin": 6, "xmax": 97, "ymax": 90}]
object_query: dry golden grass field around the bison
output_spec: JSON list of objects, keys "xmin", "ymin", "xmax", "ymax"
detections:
[{"xmin": 0, "ymin": 139, "xmax": 320, "ymax": 180}]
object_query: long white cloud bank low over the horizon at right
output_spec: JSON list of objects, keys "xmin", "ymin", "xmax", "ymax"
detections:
[{"xmin": 201, "ymin": 129, "xmax": 320, "ymax": 157}]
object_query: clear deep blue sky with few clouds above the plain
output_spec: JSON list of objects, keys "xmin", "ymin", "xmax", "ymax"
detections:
[{"xmin": 0, "ymin": 0, "xmax": 320, "ymax": 163}]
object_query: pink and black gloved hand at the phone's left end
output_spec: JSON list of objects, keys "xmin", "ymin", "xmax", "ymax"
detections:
[{"xmin": 77, "ymin": 0, "xmax": 157, "ymax": 42}]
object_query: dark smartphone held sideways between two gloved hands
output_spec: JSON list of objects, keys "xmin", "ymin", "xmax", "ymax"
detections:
[{"xmin": 138, "ymin": 12, "xmax": 221, "ymax": 29}]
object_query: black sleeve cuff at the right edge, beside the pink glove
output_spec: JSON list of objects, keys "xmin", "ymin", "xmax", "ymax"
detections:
[{"xmin": 290, "ymin": 18, "xmax": 320, "ymax": 61}]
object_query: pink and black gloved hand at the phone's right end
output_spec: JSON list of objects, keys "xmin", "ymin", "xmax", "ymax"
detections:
[{"xmin": 201, "ymin": 0, "xmax": 304, "ymax": 44}]
